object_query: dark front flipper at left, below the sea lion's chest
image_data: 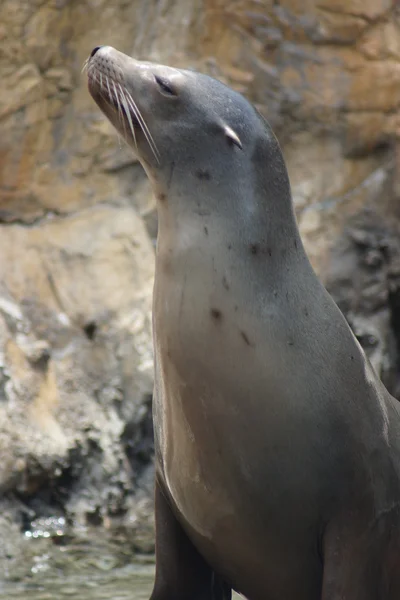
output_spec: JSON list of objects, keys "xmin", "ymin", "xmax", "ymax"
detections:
[{"xmin": 150, "ymin": 481, "xmax": 231, "ymax": 600}]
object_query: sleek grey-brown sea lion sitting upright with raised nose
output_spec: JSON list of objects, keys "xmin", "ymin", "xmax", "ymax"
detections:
[{"xmin": 87, "ymin": 46, "xmax": 400, "ymax": 600}]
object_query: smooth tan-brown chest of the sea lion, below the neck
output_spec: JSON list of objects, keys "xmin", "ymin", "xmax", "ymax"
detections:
[{"xmin": 153, "ymin": 231, "xmax": 332, "ymax": 545}]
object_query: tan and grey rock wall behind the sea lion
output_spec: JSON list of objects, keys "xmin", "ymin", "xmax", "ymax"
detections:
[{"xmin": 0, "ymin": 0, "xmax": 400, "ymax": 552}]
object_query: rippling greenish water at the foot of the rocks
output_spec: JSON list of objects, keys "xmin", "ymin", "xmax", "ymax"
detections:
[{"xmin": 0, "ymin": 529, "xmax": 154, "ymax": 600}]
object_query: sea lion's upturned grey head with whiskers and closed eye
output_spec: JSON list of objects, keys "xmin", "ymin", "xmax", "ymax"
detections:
[{"xmin": 87, "ymin": 46, "xmax": 288, "ymax": 211}]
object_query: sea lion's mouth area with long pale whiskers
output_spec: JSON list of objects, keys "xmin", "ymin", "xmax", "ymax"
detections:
[{"xmin": 82, "ymin": 55, "xmax": 160, "ymax": 163}]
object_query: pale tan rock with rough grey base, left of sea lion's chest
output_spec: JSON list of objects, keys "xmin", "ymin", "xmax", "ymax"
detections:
[{"xmin": 0, "ymin": 204, "xmax": 153, "ymax": 512}]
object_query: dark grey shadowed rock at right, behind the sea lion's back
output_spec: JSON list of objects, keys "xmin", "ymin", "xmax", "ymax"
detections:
[{"xmin": 325, "ymin": 211, "xmax": 400, "ymax": 399}]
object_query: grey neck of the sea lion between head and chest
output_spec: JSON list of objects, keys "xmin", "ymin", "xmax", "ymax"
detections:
[{"xmin": 154, "ymin": 136, "xmax": 308, "ymax": 268}]
